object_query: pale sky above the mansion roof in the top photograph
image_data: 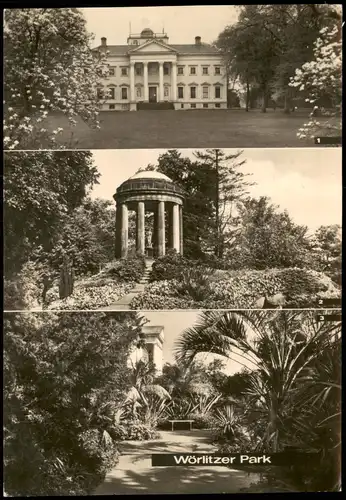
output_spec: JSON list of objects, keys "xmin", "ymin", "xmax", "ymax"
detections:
[{"xmin": 81, "ymin": 5, "xmax": 238, "ymax": 46}]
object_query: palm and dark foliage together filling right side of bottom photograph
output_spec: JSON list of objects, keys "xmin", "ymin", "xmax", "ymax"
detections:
[{"xmin": 176, "ymin": 311, "xmax": 341, "ymax": 491}]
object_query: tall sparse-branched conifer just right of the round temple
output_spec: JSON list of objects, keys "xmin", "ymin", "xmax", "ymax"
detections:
[{"xmin": 195, "ymin": 149, "xmax": 253, "ymax": 258}]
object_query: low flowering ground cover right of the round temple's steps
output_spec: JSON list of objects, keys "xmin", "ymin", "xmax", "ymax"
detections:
[{"xmin": 131, "ymin": 266, "xmax": 340, "ymax": 309}]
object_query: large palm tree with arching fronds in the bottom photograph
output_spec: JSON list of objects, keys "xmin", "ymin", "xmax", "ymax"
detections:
[{"xmin": 176, "ymin": 311, "xmax": 341, "ymax": 452}]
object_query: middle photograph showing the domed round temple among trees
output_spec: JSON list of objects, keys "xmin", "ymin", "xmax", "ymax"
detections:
[{"xmin": 4, "ymin": 148, "xmax": 342, "ymax": 311}]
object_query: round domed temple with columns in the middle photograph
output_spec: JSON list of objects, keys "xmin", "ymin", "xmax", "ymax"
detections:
[{"xmin": 114, "ymin": 171, "xmax": 184, "ymax": 258}]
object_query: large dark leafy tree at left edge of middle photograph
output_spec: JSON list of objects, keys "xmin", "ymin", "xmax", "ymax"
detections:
[{"xmin": 4, "ymin": 151, "xmax": 99, "ymax": 276}]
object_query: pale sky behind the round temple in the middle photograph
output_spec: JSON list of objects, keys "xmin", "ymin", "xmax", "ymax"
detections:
[{"xmin": 91, "ymin": 148, "xmax": 342, "ymax": 231}]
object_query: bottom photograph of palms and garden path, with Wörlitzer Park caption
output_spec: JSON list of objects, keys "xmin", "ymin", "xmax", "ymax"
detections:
[{"xmin": 4, "ymin": 310, "xmax": 341, "ymax": 496}]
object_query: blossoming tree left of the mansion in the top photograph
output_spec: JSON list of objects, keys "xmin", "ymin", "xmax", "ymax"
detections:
[{"xmin": 4, "ymin": 8, "xmax": 107, "ymax": 149}]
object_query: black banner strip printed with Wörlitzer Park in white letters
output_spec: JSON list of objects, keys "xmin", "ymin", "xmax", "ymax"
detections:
[{"xmin": 151, "ymin": 452, "xmax": 320, "ymax": 467}]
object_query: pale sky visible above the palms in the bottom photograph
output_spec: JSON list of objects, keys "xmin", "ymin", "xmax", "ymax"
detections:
[{"xmin": 139, "ymin": 311, "xmax": 260, "ymax": 375}]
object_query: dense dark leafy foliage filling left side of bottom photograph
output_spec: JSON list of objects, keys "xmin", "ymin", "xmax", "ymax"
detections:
[{"xmin": 4, "ymin": 313, "xmax": 141, "ymax": 496}]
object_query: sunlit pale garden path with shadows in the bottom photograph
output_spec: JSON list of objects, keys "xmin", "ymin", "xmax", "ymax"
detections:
[{"xmin": 94, "ymin": 430, "xmax": 259, "ymax": 495}]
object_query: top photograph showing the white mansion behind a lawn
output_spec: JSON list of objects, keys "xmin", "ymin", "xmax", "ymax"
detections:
[{"xmin": 4, "ymin": 4, "xmax": 342, "ymax": 150}]
